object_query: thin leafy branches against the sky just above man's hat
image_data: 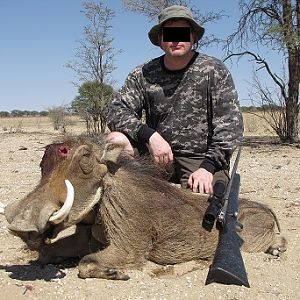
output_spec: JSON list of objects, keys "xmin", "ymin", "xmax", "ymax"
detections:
[{"xmin": 123, "ymin": 0, "xmax": 224, "ymax": 47}]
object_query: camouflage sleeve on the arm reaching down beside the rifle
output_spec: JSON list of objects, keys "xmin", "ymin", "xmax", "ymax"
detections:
[{"xmin": 202, "ymin": 61, "xmax": 244, "ymax": 173}]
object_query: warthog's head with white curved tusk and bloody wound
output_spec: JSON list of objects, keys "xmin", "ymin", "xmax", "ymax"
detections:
[{"xmin": 2, "ymin": 136, "xmax": 122, "ymax": 250}]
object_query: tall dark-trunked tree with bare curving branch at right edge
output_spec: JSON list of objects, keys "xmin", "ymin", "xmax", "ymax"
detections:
[{"xmin": 226, "ymin": 0, "xmax": 300, "ymax": 143}]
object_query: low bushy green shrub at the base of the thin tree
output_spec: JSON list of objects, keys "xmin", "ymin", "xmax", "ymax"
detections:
[{"xmin": 72, "ymin": 81, "xmax": 113, "ymax": 133}]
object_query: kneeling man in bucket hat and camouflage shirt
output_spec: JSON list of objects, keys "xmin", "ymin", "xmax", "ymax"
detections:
[{"xmin": 107, "ymin": 5, "xmax": 243, "ymax": 193}]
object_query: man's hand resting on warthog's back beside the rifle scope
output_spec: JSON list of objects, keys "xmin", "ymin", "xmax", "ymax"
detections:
[{"xmin": 188, "ymin": 168, "xmax": 213, "ymax": 194}]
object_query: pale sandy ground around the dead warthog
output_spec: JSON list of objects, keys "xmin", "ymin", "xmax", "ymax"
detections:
[{"xmin": 0, "ymin": 118, "xmax": 300, "ymax": 299}]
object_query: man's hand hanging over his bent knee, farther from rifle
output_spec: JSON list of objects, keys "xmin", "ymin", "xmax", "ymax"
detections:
[{"xmin": 148, "ymin": 132, "xmax": 173, "ymax": 166}]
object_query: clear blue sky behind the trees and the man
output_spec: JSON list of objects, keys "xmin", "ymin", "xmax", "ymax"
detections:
[{"xmin": 0, "ymin": 0, "xmax": 282, "ymax": 111}]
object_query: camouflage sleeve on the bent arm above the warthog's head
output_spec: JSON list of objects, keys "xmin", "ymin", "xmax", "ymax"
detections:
[{"xmin": 107, "ymin": 68, "xmax": 144, "ymax": 141}]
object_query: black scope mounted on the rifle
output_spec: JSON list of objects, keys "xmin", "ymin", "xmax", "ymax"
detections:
[{"xmin": 202, "ymin": 181, "xmax": 225, "ymax": 231}]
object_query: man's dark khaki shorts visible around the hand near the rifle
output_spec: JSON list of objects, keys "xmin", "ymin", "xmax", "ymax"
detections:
[{"xmin": 168, "ymin": 156, "xmax": 229, "ymax": 188}]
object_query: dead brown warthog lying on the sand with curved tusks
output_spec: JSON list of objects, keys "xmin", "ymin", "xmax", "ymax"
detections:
[{"xmin": 0, "ymin": 136, "xmax": 286, "ymax": 280}]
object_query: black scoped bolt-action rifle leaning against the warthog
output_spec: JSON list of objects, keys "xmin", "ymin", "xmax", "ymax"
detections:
[{"xmin": 202, "ymin": 148, "xmax": 250, "ymax": 287}]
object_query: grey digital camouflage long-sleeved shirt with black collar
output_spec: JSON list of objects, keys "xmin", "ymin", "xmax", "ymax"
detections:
[{"xmin": 108, "ymin": 52, "xmax": 243, "ymax": 173}]
